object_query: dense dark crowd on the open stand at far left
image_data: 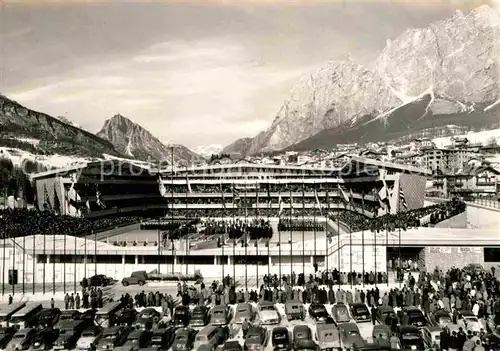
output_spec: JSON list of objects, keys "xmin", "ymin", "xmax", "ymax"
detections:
[{"xmin": 0, "ymin": 208, "xmax": 142, "ymax": 238}]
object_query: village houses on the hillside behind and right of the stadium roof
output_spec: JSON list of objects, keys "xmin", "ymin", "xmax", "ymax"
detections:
[{"xmin": 208, "ymin": 131, "xmax": 500, "ymax": 201}]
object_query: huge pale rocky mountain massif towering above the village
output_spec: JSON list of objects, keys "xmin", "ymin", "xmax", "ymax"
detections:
[{"xmin": 228, "ymin": 5, "xmax": 500, "ymax": 154}]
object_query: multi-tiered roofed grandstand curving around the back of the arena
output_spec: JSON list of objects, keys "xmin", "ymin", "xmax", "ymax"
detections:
[{"xmin": 33, "ymin": 156, "xmax": 429, "ymax": 218}]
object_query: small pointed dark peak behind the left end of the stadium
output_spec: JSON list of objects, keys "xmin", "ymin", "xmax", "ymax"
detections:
[{"xmin": 97, "ymin": 114, "xmax": 204, "ymax": 165}]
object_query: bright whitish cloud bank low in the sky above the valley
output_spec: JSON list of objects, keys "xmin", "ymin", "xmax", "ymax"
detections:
[{"xmin": 11, "ymin": 39, "xmax": 311, "ymax": 147}]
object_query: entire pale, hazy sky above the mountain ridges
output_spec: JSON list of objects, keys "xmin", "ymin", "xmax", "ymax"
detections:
[{"xmin": 0, "ymin": 0, "xmax": 494, "ymax": 148}]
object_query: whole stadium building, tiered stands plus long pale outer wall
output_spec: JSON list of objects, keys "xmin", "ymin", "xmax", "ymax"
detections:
[{"xmin": 0, "ymin": 157, "xmax": 499, "ymax": 292}]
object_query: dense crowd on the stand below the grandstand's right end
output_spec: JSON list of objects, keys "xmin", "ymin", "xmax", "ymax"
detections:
[{"xmin": 330, "ymin": 199, "xmax": 466, "ymax": 232}]
